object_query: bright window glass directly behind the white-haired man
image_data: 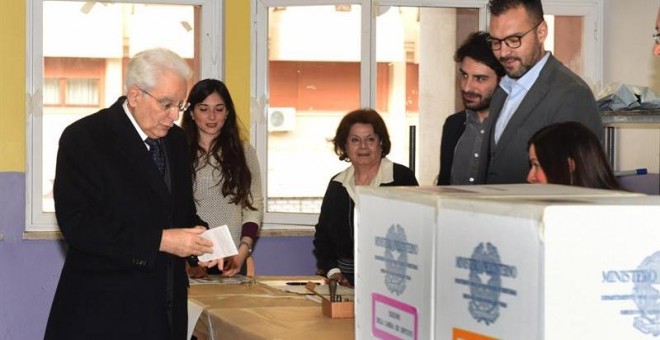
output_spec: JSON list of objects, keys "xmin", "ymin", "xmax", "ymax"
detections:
[{"xmin": 32, "ymin": 1, "xmax": 200, "ymax": 218}]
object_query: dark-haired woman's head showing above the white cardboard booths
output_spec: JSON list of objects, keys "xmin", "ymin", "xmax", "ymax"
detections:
[{"xmin": 527, "ymin": 122, "xmax": 621, "ymax": 190}]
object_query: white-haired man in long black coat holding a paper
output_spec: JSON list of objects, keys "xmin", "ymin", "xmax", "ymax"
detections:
[{"xmin": 44, "ymin": 49, "xmax": 213, "ymax": 340}]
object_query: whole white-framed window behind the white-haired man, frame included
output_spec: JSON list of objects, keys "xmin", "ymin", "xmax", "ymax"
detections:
[{"xmin": 26, "ymin": 0, "xmax": 222, "ymax": 231}]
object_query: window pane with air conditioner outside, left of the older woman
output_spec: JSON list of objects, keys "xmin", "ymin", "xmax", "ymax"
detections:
[{"xmin": 266, "ymin": 5, "xmax": 361, "ymax": 213}]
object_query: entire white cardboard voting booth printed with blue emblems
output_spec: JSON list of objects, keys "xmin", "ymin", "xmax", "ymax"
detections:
[{"xmin": 355, "ymin": 184, "xmax": 660, "ymax": 340}]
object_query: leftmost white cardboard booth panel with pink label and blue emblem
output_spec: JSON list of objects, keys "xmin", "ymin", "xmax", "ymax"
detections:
[{"xmin": 355, "ymin": 193, "xmax": 437, "ymax": 339}]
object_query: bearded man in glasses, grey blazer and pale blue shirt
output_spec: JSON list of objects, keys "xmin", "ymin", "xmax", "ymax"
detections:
[{"xmin": 480, "ymin": 0, "xmax": 603, "ymax": 183}]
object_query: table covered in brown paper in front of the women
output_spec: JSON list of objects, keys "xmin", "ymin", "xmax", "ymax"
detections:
[{"xmin": 188, "ymin": 276, "xmax": 355, "ymax": 340}]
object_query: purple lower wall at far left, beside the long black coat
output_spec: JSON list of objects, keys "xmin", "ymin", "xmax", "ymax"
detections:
[{"xmin": 0, "ymin": 173, "xmax": 64, "ymax": 339}]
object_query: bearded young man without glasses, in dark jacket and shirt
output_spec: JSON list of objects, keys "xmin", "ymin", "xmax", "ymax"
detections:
[{"xmin": 438, "ymin": 32, "xmax": 504, "ymax": 185}]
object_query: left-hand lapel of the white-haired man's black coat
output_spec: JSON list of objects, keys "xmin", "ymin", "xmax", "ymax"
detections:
[{"xmin": 108, "ymin": 97, "xmax": 172, "ymax": 206}]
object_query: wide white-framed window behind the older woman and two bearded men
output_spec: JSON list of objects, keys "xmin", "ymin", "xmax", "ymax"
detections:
[{"xmin": 251, "ymin": 0, "xmax": 602, "ymax": 228}]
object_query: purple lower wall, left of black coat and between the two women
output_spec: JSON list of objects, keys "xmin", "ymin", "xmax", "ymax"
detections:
[{"xmin": 0, "ymin": 172, "xmax": 315, "ymax": 340}]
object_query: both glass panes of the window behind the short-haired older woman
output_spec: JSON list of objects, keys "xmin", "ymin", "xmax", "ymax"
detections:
[{"xmin": 266, "ymin": 5, "xmax": 479, "ymax": 213}]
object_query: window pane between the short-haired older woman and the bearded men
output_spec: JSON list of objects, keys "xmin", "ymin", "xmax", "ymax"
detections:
[{"xmin": 376, "ymin": 6, "xmax": 479, "ymax": 184}]
